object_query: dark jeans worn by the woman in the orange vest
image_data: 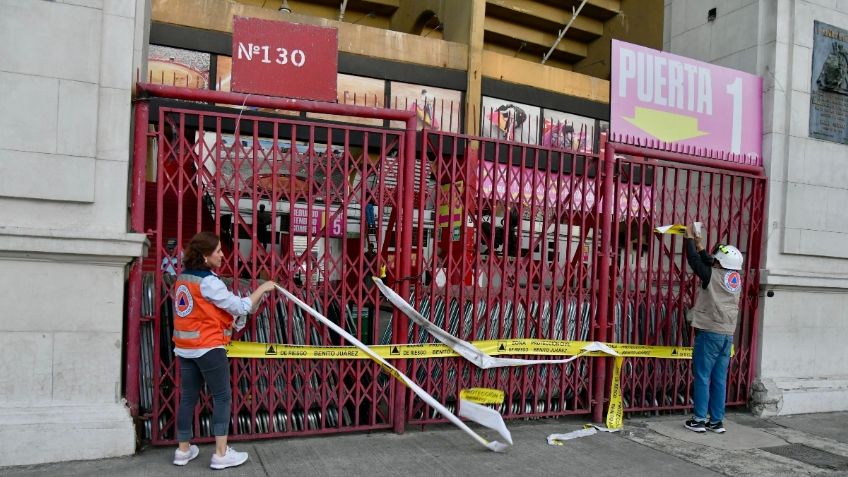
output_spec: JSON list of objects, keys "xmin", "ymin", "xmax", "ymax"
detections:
[{"xmin": 177, "ymin": 348, "xmax": 233, "ymax": 442}]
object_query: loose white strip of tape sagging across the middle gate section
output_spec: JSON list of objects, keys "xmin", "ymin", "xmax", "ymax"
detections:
[{"xmin": 371, "ymin": 277, "xmax": 618, "ymax": 369}]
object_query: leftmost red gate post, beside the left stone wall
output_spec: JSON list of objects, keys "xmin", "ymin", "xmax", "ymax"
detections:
[{"xmin": 125, "ymin": 100, "xmax": 150, "ymax": 417}]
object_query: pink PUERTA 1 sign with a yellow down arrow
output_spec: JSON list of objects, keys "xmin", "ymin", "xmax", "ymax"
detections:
[{"xmin": 610, "ymin": 40, "xmax": 763, "ymax": 157}]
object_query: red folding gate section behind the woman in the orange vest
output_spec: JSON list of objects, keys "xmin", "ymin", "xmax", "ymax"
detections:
[{"xmin": 127, "ymin": 85, "xmax": 414, "ymax": 444}]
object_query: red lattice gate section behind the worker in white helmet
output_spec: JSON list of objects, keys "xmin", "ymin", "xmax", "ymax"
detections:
[{"xmin": 601, "ymin": 142, "xmax": 767, "ymax": 411}]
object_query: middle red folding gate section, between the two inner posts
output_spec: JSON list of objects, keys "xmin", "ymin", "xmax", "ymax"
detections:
[{"xmin": 407, "ymin": 132, "xmax": 601, "ymax": 423}]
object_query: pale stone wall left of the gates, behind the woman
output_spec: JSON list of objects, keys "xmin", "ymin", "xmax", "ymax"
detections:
[{"xmin": 0, "ymin": 0, "xmax": 149, "ymax": 466}]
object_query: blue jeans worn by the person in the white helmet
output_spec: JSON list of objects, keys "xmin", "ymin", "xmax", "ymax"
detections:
[{"xmin": 692, "ymin": 330, "xmax": 733, "ymax": 422}]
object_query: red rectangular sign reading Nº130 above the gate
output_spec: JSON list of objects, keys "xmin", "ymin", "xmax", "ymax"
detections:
[{"xmin": 231, "ymin": 17, "xmax": 339, "ymax": 101}]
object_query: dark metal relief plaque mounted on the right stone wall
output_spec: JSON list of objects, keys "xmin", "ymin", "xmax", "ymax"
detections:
[{"xmin": 810, "ymin": 21, "xmax": 848, "ymax": 144}]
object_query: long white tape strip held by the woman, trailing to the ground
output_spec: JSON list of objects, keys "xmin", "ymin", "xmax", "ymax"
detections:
[{"xmin": 277, "ymin": 285, "xmax": 512, "ymax": 452}]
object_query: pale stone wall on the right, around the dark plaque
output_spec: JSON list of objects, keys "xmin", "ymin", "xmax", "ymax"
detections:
[{"xmin": 664, "ymin": 0, "xmax": 848, "ymax": 414}]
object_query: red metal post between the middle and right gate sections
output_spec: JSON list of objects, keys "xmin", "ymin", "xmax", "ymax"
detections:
[{"xmin": 592, "ymin": 142, "xmax": 616, "ymax": 422}]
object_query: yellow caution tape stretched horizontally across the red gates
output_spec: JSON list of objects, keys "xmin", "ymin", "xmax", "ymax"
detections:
[{"xmin": 227, "ymin": 338, "xmax": 692, "ymax": 359}]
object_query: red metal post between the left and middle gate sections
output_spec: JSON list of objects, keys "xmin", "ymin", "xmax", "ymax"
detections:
[{"xmin": 392, "ymin": 116, "xmax": 423, "ymax": 434}]
